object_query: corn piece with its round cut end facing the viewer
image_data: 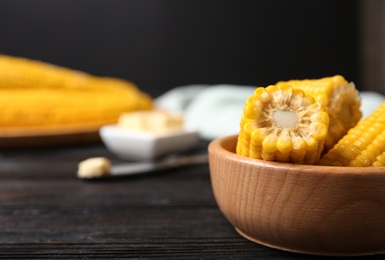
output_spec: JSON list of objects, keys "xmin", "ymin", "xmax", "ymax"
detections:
[{"xmin": 236, "ymin": 83, "xmax": 329, "ymax": 164}]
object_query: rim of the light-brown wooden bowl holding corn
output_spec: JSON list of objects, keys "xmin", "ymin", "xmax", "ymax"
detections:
[{"xmin": 208, "ymin": 134, "xmax": 385, "ymax": 176}]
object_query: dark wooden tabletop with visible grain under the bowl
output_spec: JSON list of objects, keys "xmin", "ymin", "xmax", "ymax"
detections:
[{"xmin": 0, "ymin": 139, "xmax": 384, "ymax": 259}]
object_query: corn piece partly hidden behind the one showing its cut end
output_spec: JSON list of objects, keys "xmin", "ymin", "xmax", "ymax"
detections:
[{"xmin": 277, "ymin": 75, "xmax": 362, "ymax": 151}]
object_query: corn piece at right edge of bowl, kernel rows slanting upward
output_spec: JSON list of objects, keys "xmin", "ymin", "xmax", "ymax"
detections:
[{"xmin": 319, "ymin": 99, "xmax": 385, "ymax": 167}]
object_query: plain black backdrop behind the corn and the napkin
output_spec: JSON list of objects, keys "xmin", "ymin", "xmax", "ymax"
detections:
[{"xmin": 0, "ymin": 0, "xmax": 361, "ymax": 96}]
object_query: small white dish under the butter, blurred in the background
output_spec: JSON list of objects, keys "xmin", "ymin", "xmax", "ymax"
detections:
[{"xmin": 99, "ymin": 125, "xmax": 199, "ymax": 160}]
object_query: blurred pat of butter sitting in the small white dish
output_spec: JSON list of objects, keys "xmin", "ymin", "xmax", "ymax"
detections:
[{"xmin": 117, "ymin": 110, "xmax": 184, "ymax": 132}]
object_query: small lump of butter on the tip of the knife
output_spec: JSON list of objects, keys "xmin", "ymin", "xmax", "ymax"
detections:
[{"xmin": 78, "ymin": 157, "xmax": 111, "ymax": 178}]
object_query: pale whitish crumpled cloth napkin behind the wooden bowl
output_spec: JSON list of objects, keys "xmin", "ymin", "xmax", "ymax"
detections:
[{"xmin": 155, "ymin": 84, "xmax": 385, "ymax": 140}]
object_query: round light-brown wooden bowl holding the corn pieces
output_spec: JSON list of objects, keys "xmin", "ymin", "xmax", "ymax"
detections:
[{"xmin": 209, "ymin": 136, "xmax": 385, "ymax": 256}]
